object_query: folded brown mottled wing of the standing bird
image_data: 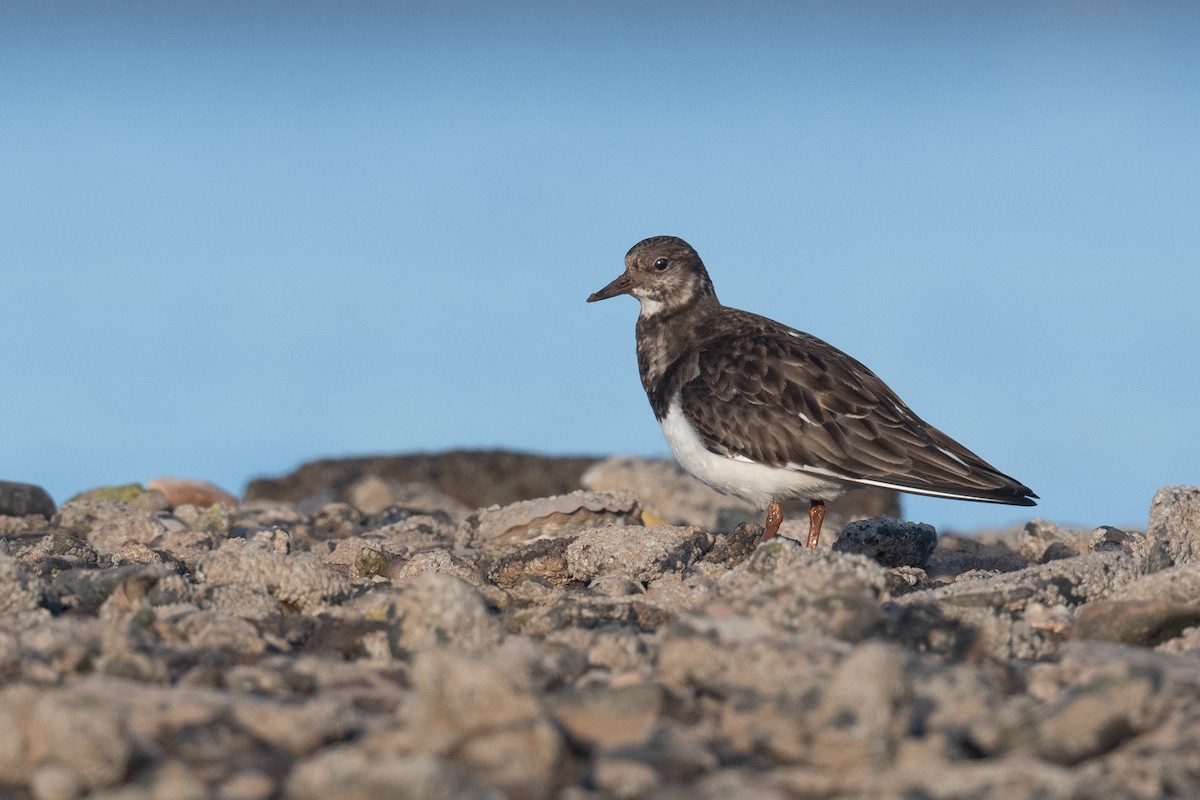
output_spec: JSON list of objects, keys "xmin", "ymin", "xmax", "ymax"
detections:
[{"xmin": 680, "ymin": 314, "xmax": 1037, "ymax": 505}]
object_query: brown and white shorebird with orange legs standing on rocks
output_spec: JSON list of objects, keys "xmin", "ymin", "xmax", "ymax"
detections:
[{"xmin": 588, "ymin": 236, "xmax": 1038, "ymax": 547}]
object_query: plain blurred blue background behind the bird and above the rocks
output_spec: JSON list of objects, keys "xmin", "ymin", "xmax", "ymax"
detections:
[{"xmin": 0, "ymin": 2, "xmax": 1200, "ymax": 529}]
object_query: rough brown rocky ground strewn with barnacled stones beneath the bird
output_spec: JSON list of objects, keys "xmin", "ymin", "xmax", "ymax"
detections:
[{"xmin": 0, "ymin": 453, "xmax": 1200, "ymax": 800}]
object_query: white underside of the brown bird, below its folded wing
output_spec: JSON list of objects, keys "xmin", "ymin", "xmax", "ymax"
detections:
[{"xmin": 662, "ymin": 397, "xmax": 848, "ymax": 509}]
